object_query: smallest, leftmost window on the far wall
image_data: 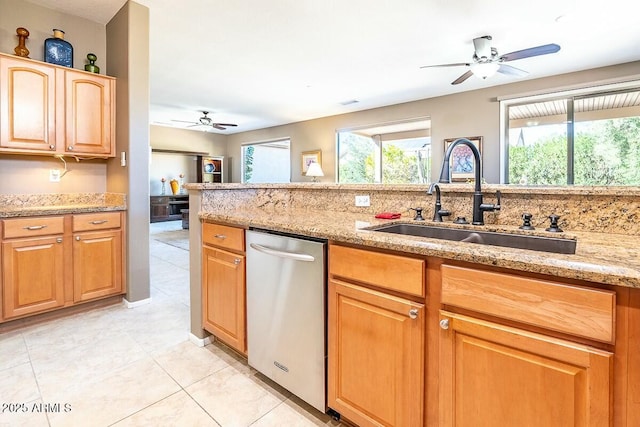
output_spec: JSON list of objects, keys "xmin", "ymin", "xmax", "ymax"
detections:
[{"xmin": 242, "ymin": 138, "xmax": 291, "ymax": 183}]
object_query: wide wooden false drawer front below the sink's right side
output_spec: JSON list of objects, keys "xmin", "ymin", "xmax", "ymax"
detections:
[{"xmin": 441, "ymin": 265, "xmax": 616, "ymax": 343}]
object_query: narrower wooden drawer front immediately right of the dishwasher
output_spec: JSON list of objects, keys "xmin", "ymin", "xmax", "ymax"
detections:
[{"xmin": 329, "ymin": 245, "xmax": 426, "ymax": 296}]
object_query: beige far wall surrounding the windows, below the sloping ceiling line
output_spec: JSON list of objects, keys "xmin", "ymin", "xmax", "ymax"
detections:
[{"xmin": 227, "ymin": 62, "xmax": 640, "ymax": 183}]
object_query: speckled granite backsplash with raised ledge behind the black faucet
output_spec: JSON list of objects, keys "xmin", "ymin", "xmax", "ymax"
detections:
[{"xmin": 195, "ymin": 183, "xmax": 640, "ymax": 235}]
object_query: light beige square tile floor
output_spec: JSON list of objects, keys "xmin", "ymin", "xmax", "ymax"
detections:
[{"xmin": 0, "ymin": 221, "xmax": 340, "ymax": 427}]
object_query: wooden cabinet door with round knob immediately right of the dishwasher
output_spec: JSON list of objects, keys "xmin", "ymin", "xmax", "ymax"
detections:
[{"xmin": 328, "ymin": 280, "xmax": 425, "ymax": 426}]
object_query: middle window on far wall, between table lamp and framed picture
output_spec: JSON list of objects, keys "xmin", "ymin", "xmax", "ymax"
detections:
[{"xmin": 337, "ymin": 119, "xmax": 431, "ymax": 184}]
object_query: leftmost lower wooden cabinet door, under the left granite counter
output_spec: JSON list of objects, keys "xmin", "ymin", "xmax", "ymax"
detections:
[{"xmin": 2, "ymin": 236, "xmax": 64, "ymax": 319}]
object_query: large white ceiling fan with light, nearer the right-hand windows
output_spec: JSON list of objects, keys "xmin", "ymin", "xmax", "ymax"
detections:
[{"xmin": 420, "ymin": 36, "xmax": 560, "ymax": 85}]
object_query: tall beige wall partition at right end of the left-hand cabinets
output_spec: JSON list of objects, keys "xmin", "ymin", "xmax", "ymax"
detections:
[{"xmin": 107, "ymin": 1, "xmax": 150, "ymax": 302}]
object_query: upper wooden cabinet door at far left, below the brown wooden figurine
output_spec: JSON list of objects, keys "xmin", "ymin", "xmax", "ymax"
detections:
[{"xmin": 0, "ymin": 56, "xmax": 60, "ymax": 153}]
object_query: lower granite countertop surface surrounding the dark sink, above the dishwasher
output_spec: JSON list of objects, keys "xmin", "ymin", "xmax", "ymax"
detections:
[{"xmin": 199, "ymin": 209, "xmax": 640, "ymax": 288}]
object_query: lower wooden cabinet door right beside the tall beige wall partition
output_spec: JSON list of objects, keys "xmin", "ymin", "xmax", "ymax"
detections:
[{"xmin": 73, "ymin": 230, "xmax": 123, "ymax": 302}]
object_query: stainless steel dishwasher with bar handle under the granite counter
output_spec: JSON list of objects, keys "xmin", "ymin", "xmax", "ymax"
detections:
[{"xmin": 246, "ymin": 230, "xmax": 327, "ymax": 412}]
